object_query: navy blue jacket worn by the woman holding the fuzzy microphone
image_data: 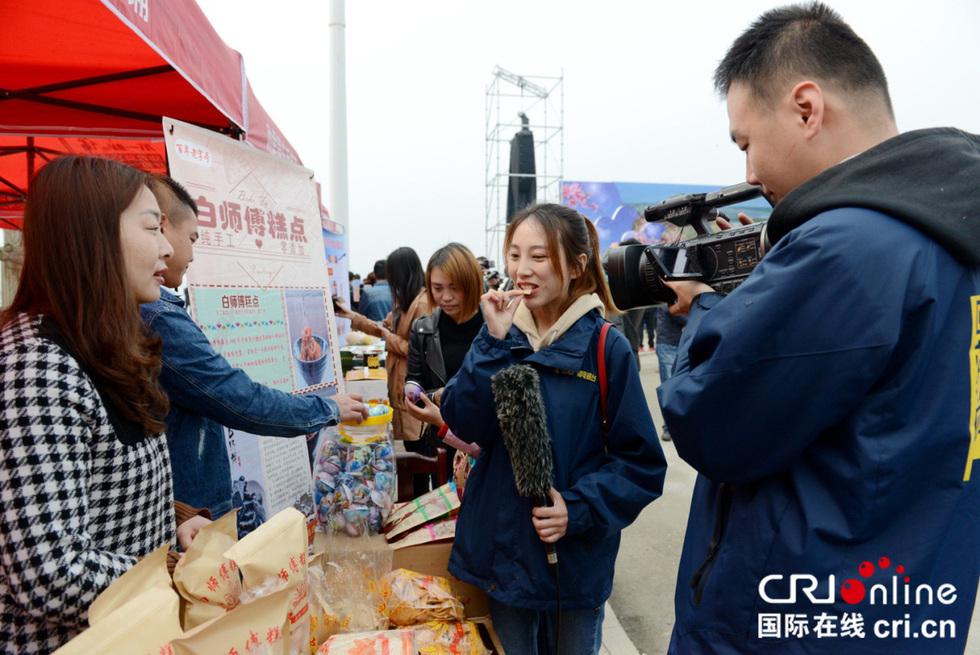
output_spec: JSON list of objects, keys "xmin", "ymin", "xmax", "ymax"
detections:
[{"xmin": 442, "ymin": 310, "xmax": 667, "ymax": 609}]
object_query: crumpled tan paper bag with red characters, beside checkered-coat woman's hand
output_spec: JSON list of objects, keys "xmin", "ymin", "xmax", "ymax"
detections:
[{"xmin": 174, "ymin": 511, "xmax": 242, "ymax": 630}]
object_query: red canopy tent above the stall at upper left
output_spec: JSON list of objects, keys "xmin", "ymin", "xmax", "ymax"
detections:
[{"xmin": 0, "ymin": 0, "xmax": 299, "ymax": 228}]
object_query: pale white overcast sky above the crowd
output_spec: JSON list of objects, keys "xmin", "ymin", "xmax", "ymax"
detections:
[{"xmin": 198, "ymin": 0, "xmax": 980, "ymax": 274}]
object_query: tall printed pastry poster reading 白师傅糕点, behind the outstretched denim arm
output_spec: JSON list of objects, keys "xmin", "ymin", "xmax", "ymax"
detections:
[{"xmin": 163, "ymin": 118, "xmax": 346, "ymax": 531}]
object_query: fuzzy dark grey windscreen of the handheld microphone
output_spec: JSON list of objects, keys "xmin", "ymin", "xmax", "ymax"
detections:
[{"xmin": 490, "ymin": 364, "xmax": 554, "ymax": 499}]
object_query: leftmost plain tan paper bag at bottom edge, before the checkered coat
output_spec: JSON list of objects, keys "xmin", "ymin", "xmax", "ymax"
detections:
[{"xmin": 55, "ymin": 587, "xmax": 181, "ymax": 655}]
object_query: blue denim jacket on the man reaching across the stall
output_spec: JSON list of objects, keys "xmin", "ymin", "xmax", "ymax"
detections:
[{"xmin": 140, "ymin": 289, "xmax": 340, "ymax": 518}]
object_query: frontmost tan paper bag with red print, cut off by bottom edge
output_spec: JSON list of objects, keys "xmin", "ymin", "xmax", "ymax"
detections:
[{"xmin": 170, "ymin": 589, "xmax": 292, "ymax": 655}]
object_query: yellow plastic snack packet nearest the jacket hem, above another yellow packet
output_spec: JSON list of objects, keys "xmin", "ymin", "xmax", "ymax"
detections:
[{"xmin": 384, "ymin": 569, "xmax": 464, "ymax": 626}]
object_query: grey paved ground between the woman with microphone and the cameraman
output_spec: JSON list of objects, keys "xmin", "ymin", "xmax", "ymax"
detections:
[{"xmin": 603, "ymin": 353, "xmax": 980, "ymax": 655}]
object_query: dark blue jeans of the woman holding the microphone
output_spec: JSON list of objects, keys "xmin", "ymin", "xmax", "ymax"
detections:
[{"xmin": 490, "ymin": 598, "xmax": 606, "ymax": 655}]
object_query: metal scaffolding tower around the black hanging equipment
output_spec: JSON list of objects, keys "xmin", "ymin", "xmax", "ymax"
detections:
[{"xmin": 484, "ymin": 66, "xmax": 565, "ymax": 267}]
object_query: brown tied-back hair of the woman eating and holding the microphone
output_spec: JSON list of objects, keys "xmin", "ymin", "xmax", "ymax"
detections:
[{"xmin": 504, "ymin": 204, "xmax": 619, "ymax": 316}]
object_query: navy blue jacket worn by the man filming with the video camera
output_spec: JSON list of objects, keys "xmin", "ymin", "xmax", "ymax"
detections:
[{"xmin": 659, "ymin": 208, "xmax": 980, "ymax": 655}]
